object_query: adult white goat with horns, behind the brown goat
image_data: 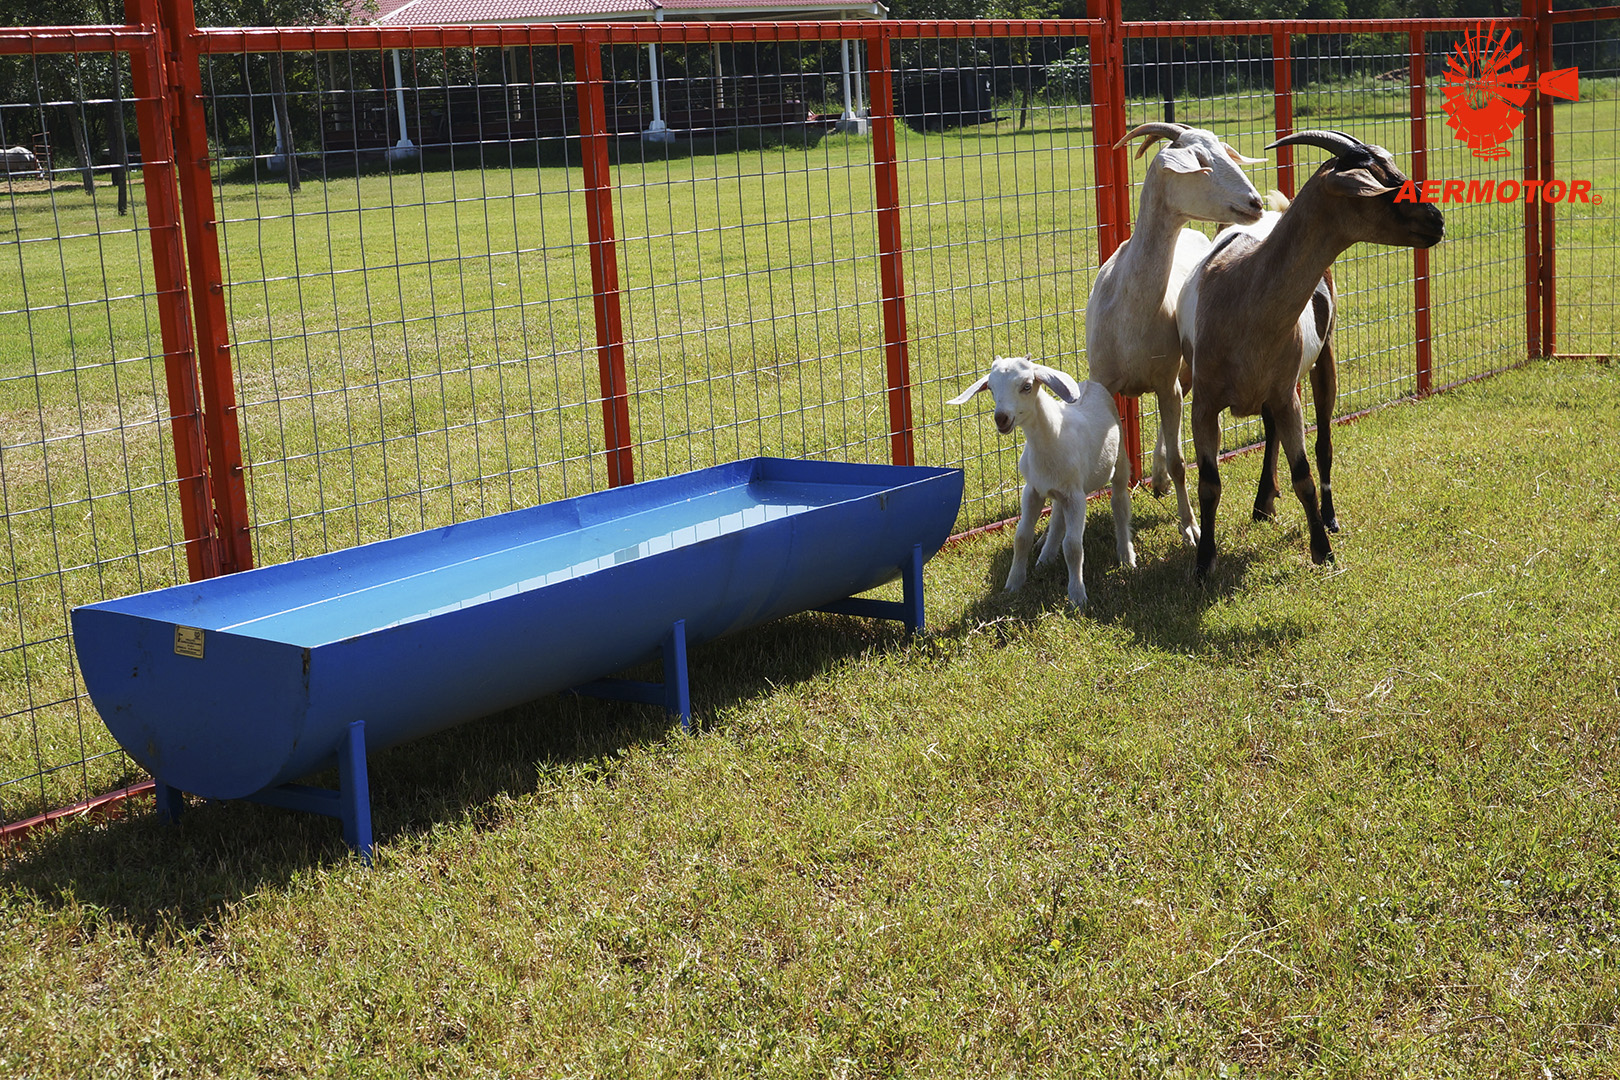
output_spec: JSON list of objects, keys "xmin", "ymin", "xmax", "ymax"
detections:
[{"xmin": 1085, "ymin": 123, "xmax": 1264, "ymax": 544}]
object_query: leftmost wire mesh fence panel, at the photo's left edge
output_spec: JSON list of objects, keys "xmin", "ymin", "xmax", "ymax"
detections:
[{"xmin": 0, "ymin": 40, "xmax": 186, "ymax": 821}]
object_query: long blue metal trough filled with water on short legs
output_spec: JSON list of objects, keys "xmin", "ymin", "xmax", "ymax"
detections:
[{"xmin": 73, "ymin": 458, "xmax": 962, "ymax": 853}]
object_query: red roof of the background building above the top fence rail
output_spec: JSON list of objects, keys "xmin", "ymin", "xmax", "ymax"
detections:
[{"xmin": 363, "ymin": 0, "xmax": 888, "ymax": 26}]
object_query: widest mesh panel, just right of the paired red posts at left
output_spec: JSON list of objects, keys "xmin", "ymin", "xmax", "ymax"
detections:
[{"xmin": 203, "ymin": 42, "xmax": 606, "ymax": 562}]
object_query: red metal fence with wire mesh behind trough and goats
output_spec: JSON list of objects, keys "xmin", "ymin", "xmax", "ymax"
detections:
[{"xmin": 0, "ymin": 0, "xmax": 1620, "ymax": 821}]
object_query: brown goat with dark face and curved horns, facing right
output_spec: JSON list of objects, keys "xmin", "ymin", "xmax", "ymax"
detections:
[{"xmin": 1176, "ymin": 131, "xmax": 1445, "ymax": 576}]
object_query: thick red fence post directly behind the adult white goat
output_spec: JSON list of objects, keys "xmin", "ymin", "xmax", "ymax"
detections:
[{"xmin": 1087, "ymin": 0, "xmax": 1142, "ymax": 484}]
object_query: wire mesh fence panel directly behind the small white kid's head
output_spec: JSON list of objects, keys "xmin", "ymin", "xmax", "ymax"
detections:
[{"xmin": 893, "ymin": 36, "xmax": 1100, "ymax": 528}]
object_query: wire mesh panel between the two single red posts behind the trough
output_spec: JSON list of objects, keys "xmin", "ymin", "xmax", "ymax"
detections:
[{"xmin": 604, "ymin": 40, "xmax": 888, "ymax": 476}]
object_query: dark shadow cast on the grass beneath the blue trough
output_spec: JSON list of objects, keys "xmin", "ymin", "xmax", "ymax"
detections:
[{"xmin": 0, "ymin": 614, "xmax": 906, "ymax": 941}]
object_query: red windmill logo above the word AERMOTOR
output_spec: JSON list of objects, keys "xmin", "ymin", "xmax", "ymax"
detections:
[{"xmin": 1440, "ymin": 23, "xmax": 1581, "ymax": 160}]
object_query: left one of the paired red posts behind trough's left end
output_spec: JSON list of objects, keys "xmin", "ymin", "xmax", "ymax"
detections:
[{"xmin": 125, "ymin": 0, "xmax": 220, "ymax": 581}]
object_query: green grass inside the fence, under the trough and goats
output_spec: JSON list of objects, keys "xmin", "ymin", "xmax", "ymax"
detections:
[{"xmin": 0, "ymin": 363, "xmax": 1620, "ymax": 1077}]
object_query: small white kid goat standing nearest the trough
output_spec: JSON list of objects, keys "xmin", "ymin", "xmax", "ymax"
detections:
[{"xmin": 951, "ymin": 356, "xmax": 1136, "ymax": 607}]
